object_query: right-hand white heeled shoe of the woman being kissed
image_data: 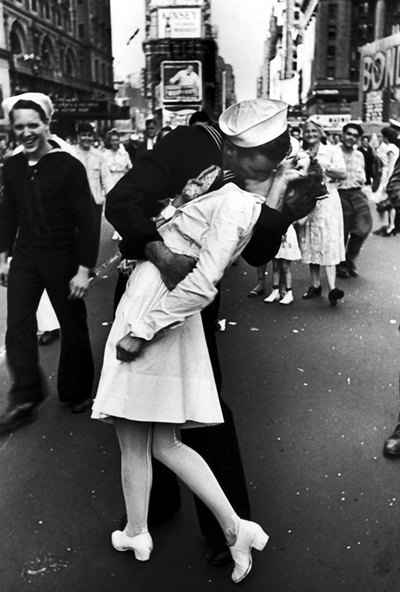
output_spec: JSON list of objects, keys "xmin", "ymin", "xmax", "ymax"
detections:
[{"xmin": 229, "ymin": 520, "xmax": 269, "ymax": 584}]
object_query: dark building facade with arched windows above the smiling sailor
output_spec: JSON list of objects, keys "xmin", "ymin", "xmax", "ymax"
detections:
[{"xmin": 0, "ymin": 0, "xmax": 114, "ymax": 131}]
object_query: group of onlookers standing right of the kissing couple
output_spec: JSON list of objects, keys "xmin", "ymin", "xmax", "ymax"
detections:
[{"xmin": 248, "ymin": 116, "xmax": 400, "ymax": 306}]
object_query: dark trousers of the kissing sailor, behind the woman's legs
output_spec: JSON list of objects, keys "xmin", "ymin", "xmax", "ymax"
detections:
[{"xmin": 114, "ymin": 274, "xmax": 250, "ymax": 546}]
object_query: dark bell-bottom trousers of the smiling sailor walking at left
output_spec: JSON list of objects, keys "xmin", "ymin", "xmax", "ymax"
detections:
[{"xmin": 6, "ymin": 249, "xmax": 94, "ymax": 405}]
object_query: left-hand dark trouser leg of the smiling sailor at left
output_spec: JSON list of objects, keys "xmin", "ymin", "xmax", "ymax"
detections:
[{"xmin": 6, "ymin": 253, "xmax": 44, "ymax": 406}]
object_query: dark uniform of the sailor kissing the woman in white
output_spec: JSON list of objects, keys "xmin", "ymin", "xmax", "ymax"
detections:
[{"xmin": 106, "ymin": 105, "xmax": 315, "ymax": 564}]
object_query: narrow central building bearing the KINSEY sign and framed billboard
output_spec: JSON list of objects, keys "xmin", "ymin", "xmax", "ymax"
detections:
[{"xmin": 143, "ymin": 0, "xmax": 235, "ymax": 126}]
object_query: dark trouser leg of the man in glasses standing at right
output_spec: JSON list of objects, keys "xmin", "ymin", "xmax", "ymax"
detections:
[{"xmin": 346, "ymin": 190, "xmax": 372, "ymax": 269}]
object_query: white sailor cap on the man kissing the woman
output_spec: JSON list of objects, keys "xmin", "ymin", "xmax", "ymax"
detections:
[{"xmin": 218, "ymin": 99, "xmax": 288, "ymax": 148}]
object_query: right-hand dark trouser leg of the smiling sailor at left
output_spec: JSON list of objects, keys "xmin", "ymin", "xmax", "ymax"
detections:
[{"xmin": 40, "ymin": 251, "xmax": 94, "ymax": 403}]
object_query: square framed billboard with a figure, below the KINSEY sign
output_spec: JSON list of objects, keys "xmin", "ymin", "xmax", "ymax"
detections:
[{"xmin": 161, "ymin": 60, "xmax": 203, "ymax": 103}]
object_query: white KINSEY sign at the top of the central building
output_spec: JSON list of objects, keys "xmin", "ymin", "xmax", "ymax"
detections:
[{"xmin": 157, "ymin": 8, "xmax": 201, "ymax": 39}]
